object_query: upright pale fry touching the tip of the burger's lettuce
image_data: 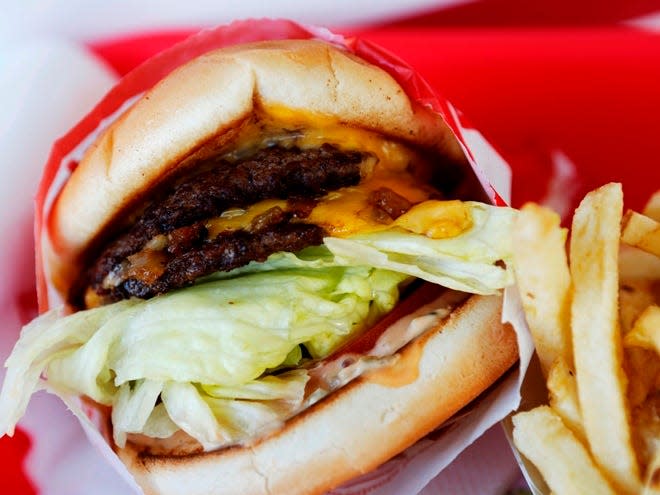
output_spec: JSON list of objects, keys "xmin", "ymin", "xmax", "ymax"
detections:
[{"xmin": 513, "ymin": 204, "xmax": 573, "ymax": 377}]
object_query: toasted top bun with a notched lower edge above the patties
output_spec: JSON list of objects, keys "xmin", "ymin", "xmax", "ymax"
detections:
[{"xmin": 45, "ymin": 40, "xmax": 464, "ymax": 292}]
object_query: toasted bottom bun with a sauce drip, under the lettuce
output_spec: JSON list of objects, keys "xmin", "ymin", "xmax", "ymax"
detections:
[{"xmin": 118, "ymin": 296, "xmax": 518, "ymax": 495}]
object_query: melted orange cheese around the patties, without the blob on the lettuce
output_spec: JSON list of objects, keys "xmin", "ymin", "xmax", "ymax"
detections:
[{"xmin": 206, "ymin": 116, "xmax": 444, "ymax": 238}]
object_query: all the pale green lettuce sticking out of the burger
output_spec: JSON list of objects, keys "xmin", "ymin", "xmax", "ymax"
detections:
[{"xmin": 0, "ymin": 203, "xmax": 515, "ymax": 449}]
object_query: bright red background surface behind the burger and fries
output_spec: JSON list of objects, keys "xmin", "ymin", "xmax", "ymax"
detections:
[{"xmin": 0, "ymin": 0, "xmax": 660, "ymax": 495}]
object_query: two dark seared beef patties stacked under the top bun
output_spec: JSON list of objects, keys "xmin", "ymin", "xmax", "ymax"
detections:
[{"xmin": 79, "ymin": 144, "xmax": 366, "ymax": 306}]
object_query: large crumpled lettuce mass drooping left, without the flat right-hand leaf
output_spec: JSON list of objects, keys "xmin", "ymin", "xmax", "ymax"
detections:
[{"xmin": 0, "ymin": 256, "xmax": 408, "ymax": 448}]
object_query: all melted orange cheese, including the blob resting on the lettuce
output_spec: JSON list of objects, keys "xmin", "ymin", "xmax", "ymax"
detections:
[{"xmin": 193, "ymin": 113, "xmax": 471, "ymax": 242}]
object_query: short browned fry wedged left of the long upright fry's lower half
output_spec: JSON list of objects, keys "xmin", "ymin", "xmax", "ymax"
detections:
[{"xmin": 547, "ymin": 359, "xmax": 587, "ymax": 445}]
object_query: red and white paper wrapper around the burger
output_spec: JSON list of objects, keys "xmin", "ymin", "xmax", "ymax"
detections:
[{"xmin": 35, "ymin": 19, "xmax": 533, "ymax": 495}]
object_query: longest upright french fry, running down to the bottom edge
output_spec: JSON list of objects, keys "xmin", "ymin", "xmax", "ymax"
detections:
[{"xmin": 570, "ymin": 183, "xmax": 641, "ymax": 493}]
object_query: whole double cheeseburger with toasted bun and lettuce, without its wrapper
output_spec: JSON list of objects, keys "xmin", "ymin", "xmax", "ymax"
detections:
[{"xmin": 0, "ymin": 41, "xmax": 517, "ymax": 495}]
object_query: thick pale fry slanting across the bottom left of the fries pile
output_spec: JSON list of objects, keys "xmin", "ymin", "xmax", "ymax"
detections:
[{"xmin": 513, "ymin": 406, "xmax": 616, "ymax": 495}]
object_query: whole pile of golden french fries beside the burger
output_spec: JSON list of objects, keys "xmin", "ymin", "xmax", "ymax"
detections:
[{"xmin": 512, "ymin": 184, "xmax": 660, "ymax": 495}]
